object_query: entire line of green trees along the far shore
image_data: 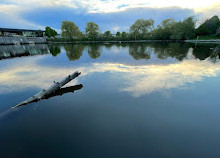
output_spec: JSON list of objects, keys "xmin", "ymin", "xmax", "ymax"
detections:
[{"xmin": 45, "ymin": 16, "xmax": 220, "ymax": 41}]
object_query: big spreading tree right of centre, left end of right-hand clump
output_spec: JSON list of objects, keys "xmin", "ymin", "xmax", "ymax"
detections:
[{"xmin": 130, "ymin": 19, "xmax": 154, "ymax": 40}]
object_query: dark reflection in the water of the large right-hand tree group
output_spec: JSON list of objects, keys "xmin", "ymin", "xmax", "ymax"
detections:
[{"xmin": 129, "ymin": 42, "xmax": 220, "ymax": 63}]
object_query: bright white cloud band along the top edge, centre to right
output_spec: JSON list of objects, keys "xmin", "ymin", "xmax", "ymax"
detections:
[{"xmin": 77, "ymin": 0, "xmax": 220, "ymax": 13}]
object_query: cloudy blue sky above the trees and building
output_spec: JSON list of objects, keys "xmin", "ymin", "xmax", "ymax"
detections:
[{"xmin": 0, "ymin": 0, "xmax": 220, "ymax": 33}]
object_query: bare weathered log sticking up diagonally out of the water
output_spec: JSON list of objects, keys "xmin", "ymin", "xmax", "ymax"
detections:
[{"xmin": 11, "ymin": 72, "xmax": 81, "ymax": 109}]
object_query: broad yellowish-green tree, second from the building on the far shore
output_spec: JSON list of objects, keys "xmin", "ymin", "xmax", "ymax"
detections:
[{"xmin": 61, "ymin": 20, "xmax": 82, "ymax": 38}]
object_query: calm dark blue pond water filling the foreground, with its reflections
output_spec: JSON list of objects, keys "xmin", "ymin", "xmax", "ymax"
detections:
[{"xmin": 0, "ymin": 43, "xmax": 220, "ymax": 158}]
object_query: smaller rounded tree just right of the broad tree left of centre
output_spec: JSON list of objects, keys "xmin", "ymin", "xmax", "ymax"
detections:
[{"xmin": 85, "ymin": 22, "xmax": 99, "ymax": 40}]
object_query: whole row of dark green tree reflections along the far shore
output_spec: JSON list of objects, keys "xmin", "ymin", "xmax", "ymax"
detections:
[{"xmin": 46, "ymin": 42, "xmax": 220, "ymax": 63}]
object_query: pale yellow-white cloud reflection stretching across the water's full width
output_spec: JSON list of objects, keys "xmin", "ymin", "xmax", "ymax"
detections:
[{"xmin": 0, "ymin": 50, "xmax": 220, "ymax": 97}]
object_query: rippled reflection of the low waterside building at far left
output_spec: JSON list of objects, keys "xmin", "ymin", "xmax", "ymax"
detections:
[{"xmin": 0, "ymin": 44, "xmax": 50, "ymax": 60}]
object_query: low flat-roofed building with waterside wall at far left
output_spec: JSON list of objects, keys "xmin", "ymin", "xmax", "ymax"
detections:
[{"xmin": 0, "ymin": 28, "xmax": 46, "ymax": 44}]
